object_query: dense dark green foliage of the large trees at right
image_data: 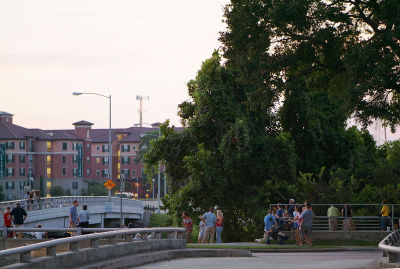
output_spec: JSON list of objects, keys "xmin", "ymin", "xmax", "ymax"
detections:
[{"xmin": 143, "ymin": 0, "xmax": 400, "ymax": 241}]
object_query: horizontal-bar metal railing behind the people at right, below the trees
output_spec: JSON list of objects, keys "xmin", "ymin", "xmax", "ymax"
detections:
[{"xmin": 269, "ymin": 203, "xmax": 400, "ymax": 231}]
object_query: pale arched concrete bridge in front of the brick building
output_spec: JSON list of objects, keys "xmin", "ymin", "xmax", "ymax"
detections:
[{"xmin": 0, "ymin": 196, "xmax": 144, "ymax": 228}]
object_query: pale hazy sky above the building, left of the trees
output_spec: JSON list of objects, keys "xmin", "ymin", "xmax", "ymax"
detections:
[{"xmin": 0, "ymin": 0, "xmax": 229, "ymax": 129}]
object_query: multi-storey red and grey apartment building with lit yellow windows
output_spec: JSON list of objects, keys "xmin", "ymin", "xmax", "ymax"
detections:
[{"xmin": 0, "ymin": 112, "xmax": 161, "ymax": 200}]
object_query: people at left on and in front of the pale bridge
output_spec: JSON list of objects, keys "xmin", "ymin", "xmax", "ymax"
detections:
[{"xmin": 3, "ymin": 198, "xmax": 90, "ymax": 239}]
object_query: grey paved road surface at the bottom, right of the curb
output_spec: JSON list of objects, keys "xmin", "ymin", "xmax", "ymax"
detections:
[{"xmin": 140, "ymin": 251, "xmax": 382, "ymax": 269}]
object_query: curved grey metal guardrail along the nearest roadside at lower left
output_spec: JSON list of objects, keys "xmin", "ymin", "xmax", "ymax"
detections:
[{"xmin": 0, "ymin": 228, "xmax": 185, "ymax": 263}]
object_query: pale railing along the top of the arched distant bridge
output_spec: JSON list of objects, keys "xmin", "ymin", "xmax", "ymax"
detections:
[{"xmin": 0, "ymin": 196, "xmax": 143, "ymax": 211}]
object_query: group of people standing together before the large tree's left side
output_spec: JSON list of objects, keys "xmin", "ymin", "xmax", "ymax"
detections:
[{"xmin": 182, "ymin": 207, "xmax": 224, "ymax": 244}]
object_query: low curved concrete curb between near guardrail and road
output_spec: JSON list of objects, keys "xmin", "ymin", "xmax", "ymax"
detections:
[{"xmin": 77, "ymin": 249, "xmax": 252, "ymax": 269}]
